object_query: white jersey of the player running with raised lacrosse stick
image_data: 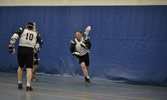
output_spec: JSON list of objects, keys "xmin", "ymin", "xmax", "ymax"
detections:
[{"xmin": 75, "ymin": 37, "xmax": 89, "ymax": 56}]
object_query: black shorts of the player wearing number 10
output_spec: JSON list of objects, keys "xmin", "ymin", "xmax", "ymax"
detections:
[{"xmin": 17, "ymin": 46, "xmax": 33, "ymax": 68}]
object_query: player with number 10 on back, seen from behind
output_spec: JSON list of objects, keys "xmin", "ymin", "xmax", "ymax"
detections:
[{"xmin": 9, "ymin": 22, "xmax": 38, "ymax": 91}]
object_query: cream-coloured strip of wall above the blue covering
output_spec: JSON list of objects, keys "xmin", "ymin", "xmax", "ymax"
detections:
[{"xmin": 0, "ymin": 0, "xmax": 167, "ymax": 6}]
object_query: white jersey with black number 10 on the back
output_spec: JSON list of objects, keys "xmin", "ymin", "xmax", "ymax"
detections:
[{"xmin": 10, "ymin": 29, "xmax": 37, "ymax": 48}]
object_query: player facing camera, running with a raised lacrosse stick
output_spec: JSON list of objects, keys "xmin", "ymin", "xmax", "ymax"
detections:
[{"xmin": 70, "ymin": 31, "xmax": 91, "ymax": 83}]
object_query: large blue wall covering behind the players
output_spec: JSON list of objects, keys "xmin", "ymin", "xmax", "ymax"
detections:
[{"xmin": 0, "ymin": 6, "xmax": 167, "ymax": 85}]
